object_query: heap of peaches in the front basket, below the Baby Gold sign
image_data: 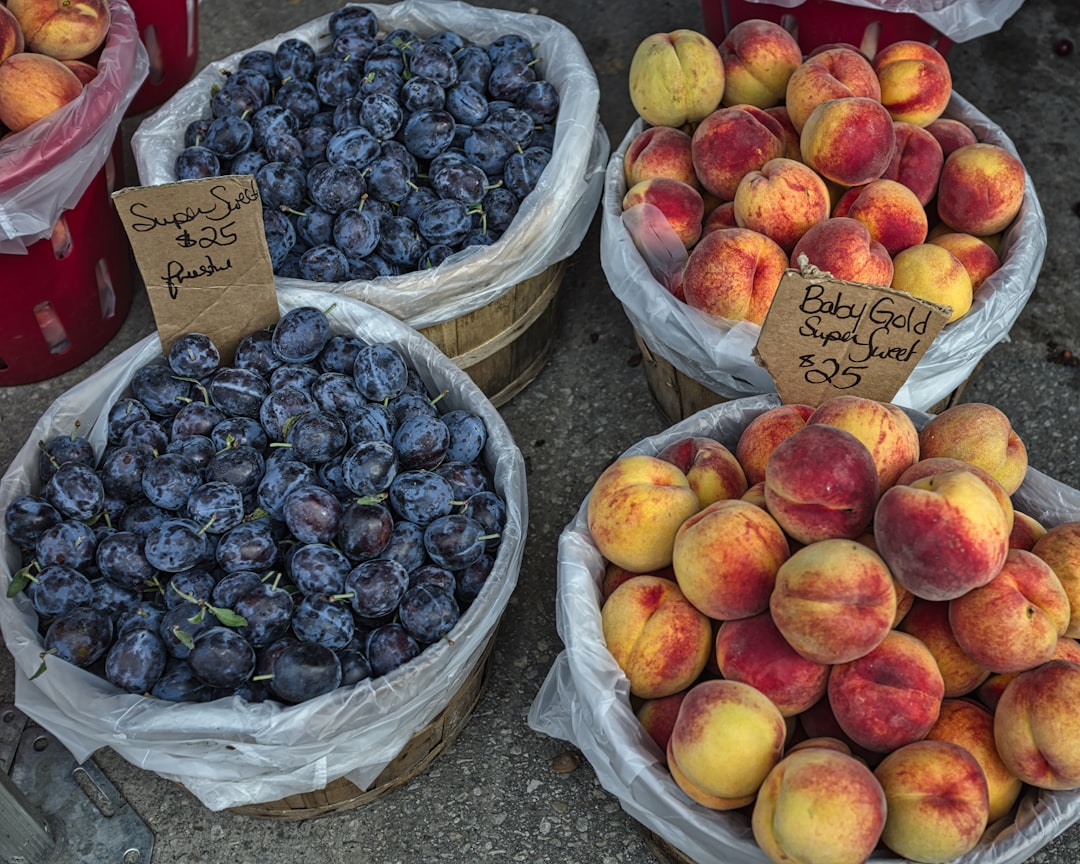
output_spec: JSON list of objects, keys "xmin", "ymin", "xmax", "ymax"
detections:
[{"xmin": 586, "ymin": 396, "xmax": 1080, "ymax": 864}]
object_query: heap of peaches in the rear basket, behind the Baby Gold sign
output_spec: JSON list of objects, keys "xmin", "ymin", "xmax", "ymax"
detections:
[{"xmin": 622, "ymin": 19, "xmax": 1025, "ymax": 324}]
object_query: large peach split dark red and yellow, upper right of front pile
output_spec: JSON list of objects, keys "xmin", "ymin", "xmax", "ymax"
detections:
[{"xmin": 874, "ymin": 471, "xmax": 1009, "ymax": 600}]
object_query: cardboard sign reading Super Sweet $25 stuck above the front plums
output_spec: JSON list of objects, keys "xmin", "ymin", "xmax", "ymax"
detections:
[{"xmin": 112, "ymin": 175, "xmax": 280, "ymax": 362}]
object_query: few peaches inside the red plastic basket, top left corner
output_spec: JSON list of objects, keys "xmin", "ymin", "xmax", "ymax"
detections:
[{"xmin": 0, "ymin": 0, "xmax": 111, "ymax": 132}]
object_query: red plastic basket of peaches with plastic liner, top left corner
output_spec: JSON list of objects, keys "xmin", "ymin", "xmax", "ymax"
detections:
[{"xmin": 0, "ymin": 0, "xmax": 148, "ymax": 387}]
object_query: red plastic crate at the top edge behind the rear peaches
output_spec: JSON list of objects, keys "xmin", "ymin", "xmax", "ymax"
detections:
[{"xmin": 701, "ymin": 0, "xmax": 953, "ymax": 56}]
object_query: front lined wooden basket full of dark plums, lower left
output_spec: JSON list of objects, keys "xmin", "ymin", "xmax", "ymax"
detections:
[{"xmin": 0, "ymin": 288, "xmax": 527, "ymax": 818}]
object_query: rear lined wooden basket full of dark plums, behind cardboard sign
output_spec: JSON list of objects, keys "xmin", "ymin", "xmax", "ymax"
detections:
[{"xmin": 132, "ymin": 0, "xmax": 609, "ymax": 404}]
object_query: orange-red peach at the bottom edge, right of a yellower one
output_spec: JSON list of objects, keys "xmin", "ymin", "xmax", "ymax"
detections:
[{"xmin": 874, "ymin": 741, "xmax": 990, "ymax": 864}]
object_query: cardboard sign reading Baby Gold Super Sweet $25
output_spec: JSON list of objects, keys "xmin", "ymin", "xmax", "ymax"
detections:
[{"xmin": 754, "ymin": 270, "xmax": 950, "ymax": 406}]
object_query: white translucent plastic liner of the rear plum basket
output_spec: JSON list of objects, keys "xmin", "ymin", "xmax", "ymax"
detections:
[{"xmin": 132, "ymin": 0, "xmax": 610, "ymax": 328}]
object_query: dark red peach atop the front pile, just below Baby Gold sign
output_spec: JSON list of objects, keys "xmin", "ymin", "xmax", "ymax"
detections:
[{"xmin": 765, "ymin": 423, "xmax": 878, "ymax": 543}]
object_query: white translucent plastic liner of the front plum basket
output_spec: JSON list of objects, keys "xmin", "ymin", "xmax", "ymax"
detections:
[{"xmin": 0, "ymin": 288, "xmax": 528, "ymax": 810}]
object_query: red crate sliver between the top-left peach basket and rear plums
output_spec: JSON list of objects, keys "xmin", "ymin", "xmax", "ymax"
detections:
[{"xmin": 125, "ymin": 0, "xmax": 199, "ymax": 117}]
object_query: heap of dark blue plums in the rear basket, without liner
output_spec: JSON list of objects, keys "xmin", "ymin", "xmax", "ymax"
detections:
[{"xmin": 176, "ymin": 4, "xmax": 559, "ymax": 282}]
